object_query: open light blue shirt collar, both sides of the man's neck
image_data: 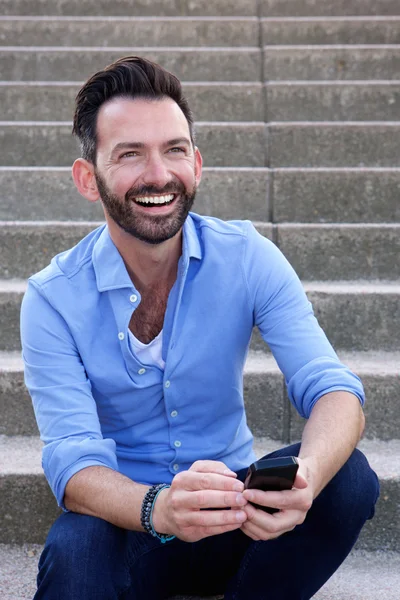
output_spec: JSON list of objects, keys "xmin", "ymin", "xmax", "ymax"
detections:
[{"xmin": 92, "ymin": 214, "xmax": 202, "ymax": 292}]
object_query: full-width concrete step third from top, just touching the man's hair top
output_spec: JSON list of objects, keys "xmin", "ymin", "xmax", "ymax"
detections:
[{"xmin": 0, "ymin": 45, "xmax": 400, "ymax": 81}]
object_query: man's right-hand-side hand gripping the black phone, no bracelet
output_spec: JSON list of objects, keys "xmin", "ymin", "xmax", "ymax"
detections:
[{"xmin": 242, "ymin": 459, "xmax": 314, "ymax": 541}]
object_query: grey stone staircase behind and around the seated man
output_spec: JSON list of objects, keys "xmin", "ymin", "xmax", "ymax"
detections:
[{"xmin": 0, "ymin": 0, "xmax": 400, "ymax": 600}]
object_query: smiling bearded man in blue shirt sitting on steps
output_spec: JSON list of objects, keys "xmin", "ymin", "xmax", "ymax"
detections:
[{"xmin": 21, "ymin": 57, "xmax": 378, "ymax": 600}]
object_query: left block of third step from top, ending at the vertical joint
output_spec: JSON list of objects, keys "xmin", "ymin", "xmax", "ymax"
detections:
[{"xmin": 0, "ymin": 47, "xmax": 261, "ymax": 81}]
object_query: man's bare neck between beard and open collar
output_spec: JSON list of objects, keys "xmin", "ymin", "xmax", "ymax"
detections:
[{"xmin": 108, "ymin": 223, "xmax": 182, "ymax": 291}]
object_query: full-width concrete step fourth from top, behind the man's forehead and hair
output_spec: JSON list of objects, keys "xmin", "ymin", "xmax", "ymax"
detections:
[{"xmin": 4, "ymin": 81, "xmax": 400, "ymax": 121}]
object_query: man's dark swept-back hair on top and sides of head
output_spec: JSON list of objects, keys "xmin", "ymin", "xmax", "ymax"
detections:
[{"xmin": 72, "ymin": 56, "xmax": 194, "ymax": 165}]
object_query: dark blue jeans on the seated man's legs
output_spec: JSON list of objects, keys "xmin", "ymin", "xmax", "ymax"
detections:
[{"xmin": 34, "ymin": 444, "xmax": 379, "ymax": 600}]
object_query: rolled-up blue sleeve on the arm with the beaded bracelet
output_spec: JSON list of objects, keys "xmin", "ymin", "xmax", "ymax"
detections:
[{"xmin": 21, "ymin": 281, "xmax": 118, "ymax": 510}]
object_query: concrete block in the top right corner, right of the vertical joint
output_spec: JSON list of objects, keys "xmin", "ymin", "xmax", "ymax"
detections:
[{"xmin": 260, "ymin": 0, "xmax": 400, "ymax": 17}]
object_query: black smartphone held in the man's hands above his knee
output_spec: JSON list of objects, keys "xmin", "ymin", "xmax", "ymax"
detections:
[{"xmin": 244, "ymin": 456, "xmax": 299, "ymax": 514}]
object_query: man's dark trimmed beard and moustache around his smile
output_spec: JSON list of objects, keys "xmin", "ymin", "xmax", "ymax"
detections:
[{"xmin": 95, "ymin": 171, "xmax": 196, "ymax": 244}]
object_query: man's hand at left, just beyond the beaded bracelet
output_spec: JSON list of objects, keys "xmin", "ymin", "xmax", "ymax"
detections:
[{"xmin": 153, "ymin": 460, "xmax": 247, "ymax": 542}]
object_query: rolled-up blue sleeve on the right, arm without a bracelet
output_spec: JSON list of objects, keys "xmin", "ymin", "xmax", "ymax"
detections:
[{"xmin": 244, "ymin": 224, "xmax": 365, "ymax": 418}]
